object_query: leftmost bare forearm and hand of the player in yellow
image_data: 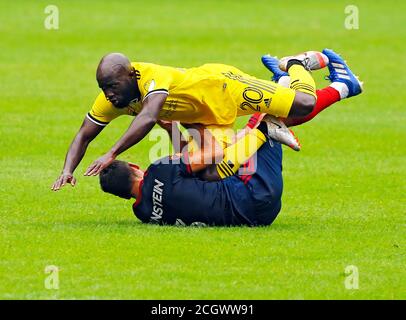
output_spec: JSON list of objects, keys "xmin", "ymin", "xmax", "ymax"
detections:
[{"xmin": 51, "ymin": 118, "xmax": 104, "ymax": 191}]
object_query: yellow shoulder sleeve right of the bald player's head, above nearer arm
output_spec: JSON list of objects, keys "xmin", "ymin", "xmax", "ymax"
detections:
[{"xmin": 138, "ymin": 64, "xmax": 173, "ymax": 101}]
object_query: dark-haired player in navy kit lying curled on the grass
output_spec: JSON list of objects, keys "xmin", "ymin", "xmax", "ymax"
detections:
[{"xmin": 100, "ymin": 119, "xmax": 283, "ymax": 226}]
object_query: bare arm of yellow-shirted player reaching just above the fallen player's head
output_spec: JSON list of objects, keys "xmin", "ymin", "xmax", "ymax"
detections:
[{"xmin": 85, "ymin": 93, "xmax": 167, "ymax": 176}]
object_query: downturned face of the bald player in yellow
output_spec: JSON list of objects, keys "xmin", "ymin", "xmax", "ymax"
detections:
[{"xmin": 98, "ymin": 73, "xmax": 138, "ymax": 108}]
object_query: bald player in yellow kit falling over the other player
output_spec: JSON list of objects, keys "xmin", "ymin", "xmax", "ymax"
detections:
[{"xmin": 52, "ymin": 51, "xmax": 328, "ymax": 190}]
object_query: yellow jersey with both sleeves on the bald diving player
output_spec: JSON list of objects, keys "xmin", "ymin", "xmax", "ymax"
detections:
[{"xmin": 88, "ymin": 62, "xmax": 243, "ymax": 125}]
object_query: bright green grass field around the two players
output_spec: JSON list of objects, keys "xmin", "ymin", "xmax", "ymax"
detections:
[{"xmin": 0, "ymin": 0, "xmax": 406, "ymax": 299}]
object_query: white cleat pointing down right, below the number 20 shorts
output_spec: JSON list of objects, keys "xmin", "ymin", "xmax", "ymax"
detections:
[{"xmin": 262, "ymin": 114, "xmax": 300, "ymax": 151}]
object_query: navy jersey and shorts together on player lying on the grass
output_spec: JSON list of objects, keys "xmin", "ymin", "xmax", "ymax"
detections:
[{"xmin": 133, "ymin": 140, "xmax": 283, "ymax": 226}]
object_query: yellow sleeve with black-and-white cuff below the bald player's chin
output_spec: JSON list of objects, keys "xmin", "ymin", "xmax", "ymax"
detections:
[{"xmin": 87, "ymin": 92, "xmax": 126, "ymax": 127}]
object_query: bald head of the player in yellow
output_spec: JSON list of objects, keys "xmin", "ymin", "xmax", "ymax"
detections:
[{"xmin": 96, "ymin": 53, "xmax": 139, "ymax": 108}]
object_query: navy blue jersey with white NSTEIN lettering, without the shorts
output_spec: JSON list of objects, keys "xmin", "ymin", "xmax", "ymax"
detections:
[{"xmin": 133, "ymin": 157, "xmax": 257, "ymax": 226}]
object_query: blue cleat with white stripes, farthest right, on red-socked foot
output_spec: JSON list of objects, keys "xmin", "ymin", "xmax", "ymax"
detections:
[{"xmin": 323, "ymin": 49, "xmax": 363, "ymax": 98}]
